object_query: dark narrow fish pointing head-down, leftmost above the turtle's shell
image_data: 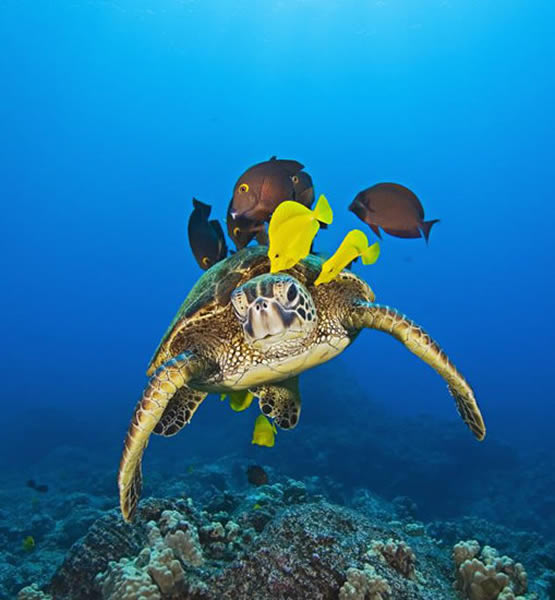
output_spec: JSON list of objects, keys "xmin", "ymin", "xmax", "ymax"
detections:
[{"xmin": 187, "ymin": 198, "xmax": 227, "ymax": 270}]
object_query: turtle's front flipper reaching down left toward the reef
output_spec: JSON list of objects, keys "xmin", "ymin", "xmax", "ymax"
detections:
[{"xmin": 118, "ymin": 352, "xmax": 212, "ymax": 521}]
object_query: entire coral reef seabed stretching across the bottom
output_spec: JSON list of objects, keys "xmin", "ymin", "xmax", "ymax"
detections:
[{"xmin": 0, "ymin": 442, "xmax": 555, "ymax": 600}]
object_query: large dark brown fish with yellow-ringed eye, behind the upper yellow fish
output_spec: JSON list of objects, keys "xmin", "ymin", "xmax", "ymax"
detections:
[{"xmin": 230, "ymin": 156, "xmax": 304, "ymax": 222}]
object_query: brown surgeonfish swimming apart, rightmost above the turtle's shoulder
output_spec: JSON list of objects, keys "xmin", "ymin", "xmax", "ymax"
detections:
[{"xmin": 349, "ymin": 183, "xmax": 439, "ymax": 241}]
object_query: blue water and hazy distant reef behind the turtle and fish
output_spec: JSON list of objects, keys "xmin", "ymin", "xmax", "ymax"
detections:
[{"xmin": 0, "ymin": 0, "xmax": 555, "ymax": 598}]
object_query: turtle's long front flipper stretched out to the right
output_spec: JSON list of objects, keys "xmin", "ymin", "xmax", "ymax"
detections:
[{"xmin": 345, "ymin": 301, "xmax": 486, "ymax": 440}]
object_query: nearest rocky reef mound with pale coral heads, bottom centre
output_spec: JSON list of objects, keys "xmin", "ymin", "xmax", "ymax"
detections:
[{"xmin": 20, "ymin": 488, "xmax": 451, "ymax": 600}]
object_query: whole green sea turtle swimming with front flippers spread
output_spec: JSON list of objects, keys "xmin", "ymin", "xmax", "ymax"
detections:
[{"xmin": 118, "ymin": 246, "xmax": 486, "ymax": 520}]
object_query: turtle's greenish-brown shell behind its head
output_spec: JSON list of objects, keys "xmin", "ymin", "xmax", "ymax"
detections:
[{"xmin": 147, "ymin": 245, "xmax": 323, "ymax": 375}]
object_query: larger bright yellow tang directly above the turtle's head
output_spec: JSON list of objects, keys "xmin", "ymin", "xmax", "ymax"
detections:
[{"xmin": 268, "ymin": 196, "xmax": 333, "ymax": 273}]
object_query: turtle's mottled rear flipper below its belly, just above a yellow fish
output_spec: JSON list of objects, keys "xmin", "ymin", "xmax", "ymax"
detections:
[{"xmin": 250, "ymin": 377, "xmax": 301, "ymax": 429}]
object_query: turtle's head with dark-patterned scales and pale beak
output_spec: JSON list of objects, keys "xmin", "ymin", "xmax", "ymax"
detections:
[{"xmin": 231, "ymin": 273, "xmax": 318, "ymax": 353}]
